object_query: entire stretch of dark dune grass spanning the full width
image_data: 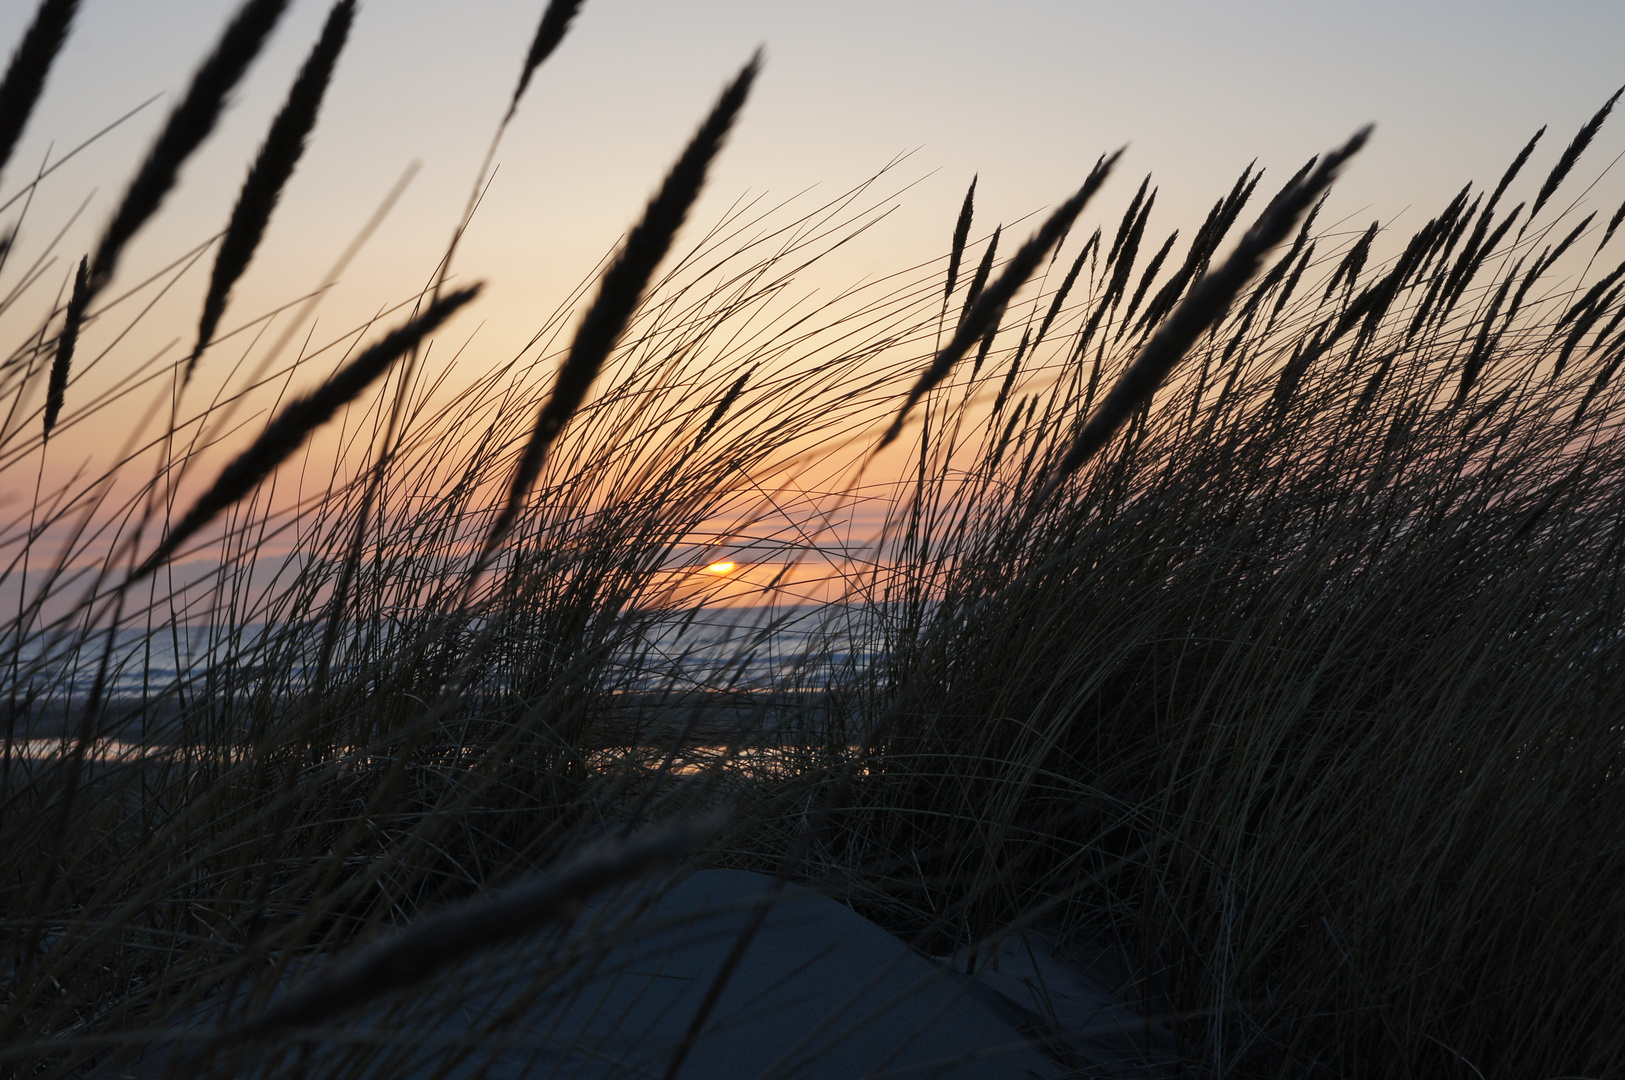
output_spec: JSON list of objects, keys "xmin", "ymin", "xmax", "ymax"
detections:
[{"xmin": 0, "ymin": 3, "xmax": 1625, "ymax": 1077}]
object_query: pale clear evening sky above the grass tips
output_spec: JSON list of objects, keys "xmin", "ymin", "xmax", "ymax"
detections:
[{"xmin": 0, "ymin": 0, "xmax": 1625, "ymax": 555}]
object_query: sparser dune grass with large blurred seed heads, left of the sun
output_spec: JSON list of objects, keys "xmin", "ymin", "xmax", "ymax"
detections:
[{"xmin": 0, "ymin": 0, "xmax": 939, "ymax": 1075}]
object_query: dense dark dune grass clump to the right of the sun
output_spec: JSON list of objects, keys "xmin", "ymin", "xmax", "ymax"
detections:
[{"xmin": 824, "ymin": 94, "xmax": 1625, "ymax": 1077}]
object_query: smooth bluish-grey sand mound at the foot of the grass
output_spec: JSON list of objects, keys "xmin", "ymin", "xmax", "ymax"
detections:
[{"xmin": 390, "ymin": 870, "xmax": 1170, "ymax": 1080}]
